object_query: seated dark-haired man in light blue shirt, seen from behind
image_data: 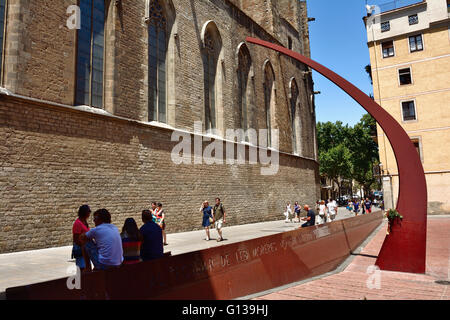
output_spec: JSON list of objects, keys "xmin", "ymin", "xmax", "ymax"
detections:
[{"xmin": 79, "ymin": 209, "xmax": 123, "ymax": 270}]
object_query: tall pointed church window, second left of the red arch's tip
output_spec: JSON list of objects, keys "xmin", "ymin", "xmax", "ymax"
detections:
[{"xmin": 148, "ymin": 0, "xmax": 167, "ymax": 123}]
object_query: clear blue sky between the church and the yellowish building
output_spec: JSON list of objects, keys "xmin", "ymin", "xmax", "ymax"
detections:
[{"xmin": 307, "ymin": 0, "xmax": 417, "ymax": 126}]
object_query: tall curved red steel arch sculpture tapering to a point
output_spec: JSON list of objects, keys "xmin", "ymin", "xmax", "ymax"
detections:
[{"xmin": 246, "ymin": 37, "xmax": 427, "ymax": 273}]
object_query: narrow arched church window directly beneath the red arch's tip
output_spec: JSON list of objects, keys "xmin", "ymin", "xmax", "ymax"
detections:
[{"xmin": 238, "ymin": 45, "xmax": 252, "ymax": 141}]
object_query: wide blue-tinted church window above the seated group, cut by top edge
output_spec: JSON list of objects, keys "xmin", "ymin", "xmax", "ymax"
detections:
[{"xmin": 75, "ymin": 0, "xmax": 105, "ymax": 108}]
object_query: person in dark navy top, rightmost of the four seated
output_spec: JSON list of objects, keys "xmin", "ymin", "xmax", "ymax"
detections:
[{"xmin": 140, "ymin": 210, "xmax": 164, "ymax": 261}]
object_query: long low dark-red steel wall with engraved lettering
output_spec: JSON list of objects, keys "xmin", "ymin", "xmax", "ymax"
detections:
[{"xmin": 6, "ymin": 211, "xmax": 382, "ymax": 300}]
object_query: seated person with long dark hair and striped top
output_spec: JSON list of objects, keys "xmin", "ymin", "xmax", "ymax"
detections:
[{"xmin": 120, "ymin": 218, "xmax": 142, "ymax": 264}]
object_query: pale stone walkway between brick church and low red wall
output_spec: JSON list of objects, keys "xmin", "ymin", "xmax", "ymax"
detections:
[{"xmin": 0, "ymin": 208, "xmax": 353, "ymax": 299}]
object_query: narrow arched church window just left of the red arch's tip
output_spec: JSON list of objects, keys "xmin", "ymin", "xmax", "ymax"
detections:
[{"xmin": 203, "ymin": 31, "xmax": 218, "ymax": 130}]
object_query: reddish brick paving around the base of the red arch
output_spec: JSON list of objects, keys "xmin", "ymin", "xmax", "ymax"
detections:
[{"xmin": 251, "ymin": 216, "xmax": 450, "ymax": 300}]
